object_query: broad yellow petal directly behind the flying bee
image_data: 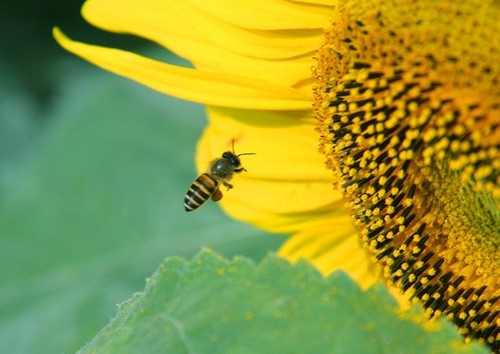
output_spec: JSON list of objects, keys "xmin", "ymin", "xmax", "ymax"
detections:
[{"xmin": 192, "ymin": 108, "xmax": 344, "ymax": 233}]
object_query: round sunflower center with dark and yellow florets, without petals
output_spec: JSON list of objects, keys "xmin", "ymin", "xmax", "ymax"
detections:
[{"xmin": 315, "ymin": 2, "xmax": 500, "ymax": 350}]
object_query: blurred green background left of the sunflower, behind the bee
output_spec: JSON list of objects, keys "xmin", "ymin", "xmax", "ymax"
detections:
[{"xmin": 0, "ymin": 0, "xmax": 282, "ymax": 353}]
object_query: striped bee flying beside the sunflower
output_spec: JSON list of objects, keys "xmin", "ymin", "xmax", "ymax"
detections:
[{"xmin": 184, "ymin": 141, "xmax": 255, "ymax": 211}]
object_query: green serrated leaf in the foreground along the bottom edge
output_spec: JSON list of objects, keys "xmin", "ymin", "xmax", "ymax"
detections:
[{"xmin": 81, "ymin": 251, "xmax": 487, "ymax": 354}]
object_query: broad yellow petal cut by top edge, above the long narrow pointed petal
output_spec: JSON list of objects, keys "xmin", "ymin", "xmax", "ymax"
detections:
[{"xmin": 82, "ymin": 0, "xmax": 322, "ymax": 60}]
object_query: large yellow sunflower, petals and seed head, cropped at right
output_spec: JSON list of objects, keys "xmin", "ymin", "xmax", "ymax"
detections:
[{"xmin": 54, "ymin": 0, "xmax": 500, "ymax": 350}]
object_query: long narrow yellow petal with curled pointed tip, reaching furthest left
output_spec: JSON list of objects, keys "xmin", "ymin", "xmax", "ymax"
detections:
[{"xmin": 53, "ymin": 28, "xmax": 311, "ymax": 110}]
